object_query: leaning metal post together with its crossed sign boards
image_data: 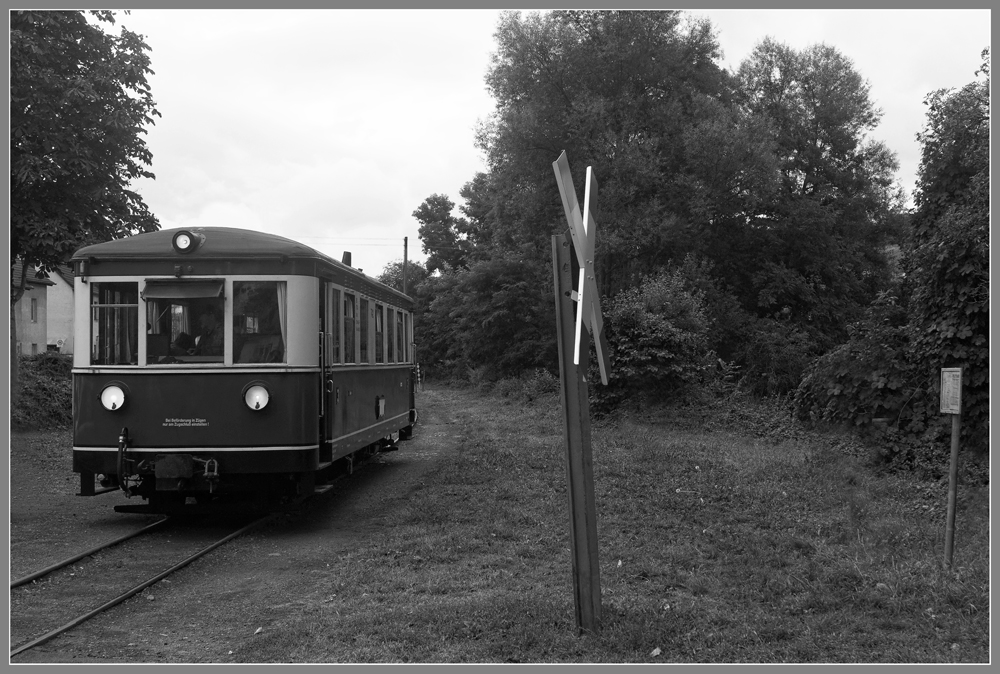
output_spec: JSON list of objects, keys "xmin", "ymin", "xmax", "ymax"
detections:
[{"xmin": 552, "ymin": 152, "xmax": 608, "ymax": 634}]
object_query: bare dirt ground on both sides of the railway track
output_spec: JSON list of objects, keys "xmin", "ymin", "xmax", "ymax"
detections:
[{"xmin": 11, "ymin": 388, "xmax": 466, "ymax": 663}]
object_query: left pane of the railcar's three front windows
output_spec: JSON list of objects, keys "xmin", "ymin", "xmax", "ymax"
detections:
[{"xmin": 90, "ymin": 282, "xmax": 139, "ymax": 365}]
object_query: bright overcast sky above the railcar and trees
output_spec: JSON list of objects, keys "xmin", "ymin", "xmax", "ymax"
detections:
[{"xmin": 118, "ymin": 10, "xmax": 990, "ymax": 276}]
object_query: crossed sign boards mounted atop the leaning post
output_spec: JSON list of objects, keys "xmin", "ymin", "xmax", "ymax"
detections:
[{"xmin": 552, "ymin": 150, "xmax": 608, "ymax": 386}]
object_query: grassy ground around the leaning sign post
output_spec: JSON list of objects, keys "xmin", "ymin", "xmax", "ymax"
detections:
[{"xmin": 232, "ymin": 390, "xmax": 989, "ymax": 663}]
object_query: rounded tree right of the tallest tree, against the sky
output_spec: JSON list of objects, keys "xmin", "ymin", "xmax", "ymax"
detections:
[{"xmin": 732, "ymin": 38, "xmax": 902, "ymax": 349}]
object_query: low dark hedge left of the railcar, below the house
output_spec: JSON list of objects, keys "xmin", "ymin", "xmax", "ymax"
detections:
[{"xmin": 10, "ymin": 352, "xmax": 73, "ymax": 430}]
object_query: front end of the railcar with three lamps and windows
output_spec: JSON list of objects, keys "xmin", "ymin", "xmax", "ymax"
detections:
[{"xmin": 73, "ymin": 228, "xmax": 321, "ymax": 509}]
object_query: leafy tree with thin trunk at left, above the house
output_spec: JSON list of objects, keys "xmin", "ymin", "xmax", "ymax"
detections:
[{"xmin": 10, "ymin": 11, "xmax": 159, "ymax": 396}]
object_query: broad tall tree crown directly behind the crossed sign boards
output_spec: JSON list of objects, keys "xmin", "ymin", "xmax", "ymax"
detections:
[{"xmin": 477, "ymin": 11, "xmax": 726, "ymax": 284}]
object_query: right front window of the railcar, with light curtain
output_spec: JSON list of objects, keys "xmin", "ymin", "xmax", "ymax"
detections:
[{"xmin": 233, "ymin": 281, "xmax": 288, "ymax": 363}]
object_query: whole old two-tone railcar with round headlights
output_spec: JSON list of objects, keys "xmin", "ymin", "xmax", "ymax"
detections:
[{"xmin": 71, "ymin": 227, "xmax": 416, "ymax": 512}]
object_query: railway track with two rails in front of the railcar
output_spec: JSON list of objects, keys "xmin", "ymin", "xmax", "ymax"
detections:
[{"xmin": 10, "ymin": 513, "xmax": 280, "ymax": 658}]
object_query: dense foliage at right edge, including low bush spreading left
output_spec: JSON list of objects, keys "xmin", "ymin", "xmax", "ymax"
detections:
[{"xmin": 796, "ymin": 52, "xmax": 989, "ymax": 454}]
